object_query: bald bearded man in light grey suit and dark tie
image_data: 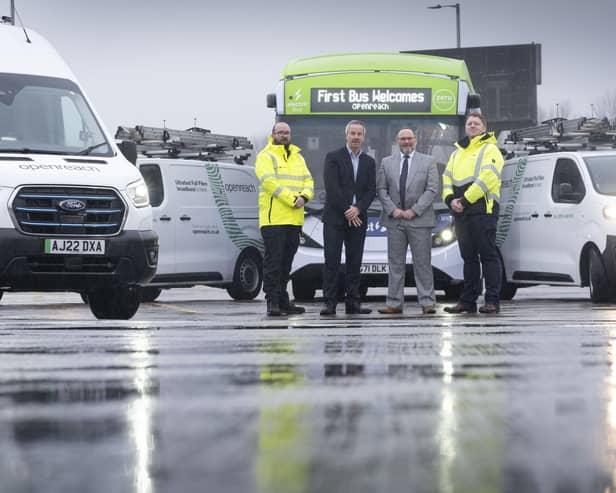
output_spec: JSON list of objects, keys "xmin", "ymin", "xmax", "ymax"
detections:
[{"xmin": 376, "ymin": 128, "xmax": 439, "ymax": 314}]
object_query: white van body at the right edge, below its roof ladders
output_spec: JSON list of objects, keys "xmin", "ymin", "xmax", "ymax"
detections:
[{"xmin": 497, "ymin": 150, "xmax": 616, "ymax": 302}]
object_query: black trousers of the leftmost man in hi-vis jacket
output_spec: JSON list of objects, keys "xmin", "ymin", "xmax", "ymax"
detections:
[{"xmin": 261, "ymin": 225, "xmax": 302, "ymax": 306}]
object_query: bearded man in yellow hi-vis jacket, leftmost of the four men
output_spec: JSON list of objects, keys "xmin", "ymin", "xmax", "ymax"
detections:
[{"xmin": 255, "ymin": 122, "xmax": 314, "ymax": 316}]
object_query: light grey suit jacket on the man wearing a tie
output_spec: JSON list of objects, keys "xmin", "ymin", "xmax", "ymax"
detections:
[{"xmin": 376, "ymin": 151, "xmax": 439, "ymax": 228}]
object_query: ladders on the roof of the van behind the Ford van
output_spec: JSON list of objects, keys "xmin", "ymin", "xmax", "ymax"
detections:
[{"xmin": 115, "ymin": 125, "xmax": 253, "ymax": 164}]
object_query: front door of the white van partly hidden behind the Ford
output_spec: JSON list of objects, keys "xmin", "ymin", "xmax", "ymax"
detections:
[{"xmin": 138, "ymin": 162, "xmax": 175, "ymax": 276}]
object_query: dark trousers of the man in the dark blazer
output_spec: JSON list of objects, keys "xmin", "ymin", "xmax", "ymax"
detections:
[{"xmin": 323, "ymin": 223, "xmax": 366, "ymax": 306}]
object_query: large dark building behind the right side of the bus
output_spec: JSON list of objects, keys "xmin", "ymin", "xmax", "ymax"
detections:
[{"xmin": 402, "ymin": 43, "xmax": 541, "ymax": 135}]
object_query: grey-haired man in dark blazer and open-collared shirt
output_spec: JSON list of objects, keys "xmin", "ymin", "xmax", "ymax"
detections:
[{"xmin": 321, "ymin": 120, "xmax": 376, "ymax": 315}]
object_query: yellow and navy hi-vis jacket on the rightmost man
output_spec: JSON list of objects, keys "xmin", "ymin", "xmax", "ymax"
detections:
[{"xmin": 443, "ymin": 132, "xmax": 504, "ymax": 214}]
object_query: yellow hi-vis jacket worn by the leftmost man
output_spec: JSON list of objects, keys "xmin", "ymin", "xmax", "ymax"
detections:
[{"xmin": 255, "ymin": 137, "xmax": 314, "ymax": 227}]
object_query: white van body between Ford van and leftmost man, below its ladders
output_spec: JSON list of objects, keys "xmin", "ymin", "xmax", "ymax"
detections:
[{"xmin": 137, "ymin": 158, "xmax": 263, "ymax": 301}]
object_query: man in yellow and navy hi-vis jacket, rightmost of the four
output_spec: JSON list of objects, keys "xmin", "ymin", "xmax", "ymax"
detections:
[{"xmin": 443, "ymin": 113, "xmax": 504, "ymax": 313}]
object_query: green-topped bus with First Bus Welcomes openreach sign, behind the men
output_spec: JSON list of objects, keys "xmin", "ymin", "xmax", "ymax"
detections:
[{"xmin": 267, "ymin": 53, "xmax": 479, "ymax": 299}]
